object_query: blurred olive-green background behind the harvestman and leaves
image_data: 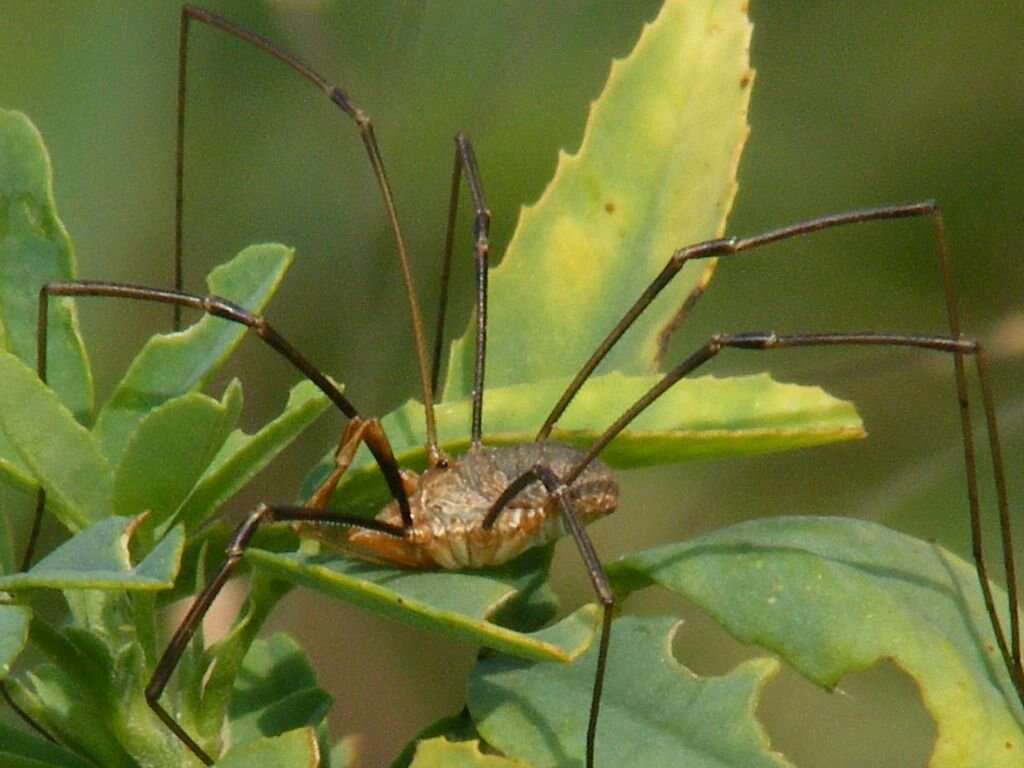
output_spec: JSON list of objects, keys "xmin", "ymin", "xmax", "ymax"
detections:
[{"xmin": 0, "ymin": 0, "xmax": 1024, "ymax": 766}]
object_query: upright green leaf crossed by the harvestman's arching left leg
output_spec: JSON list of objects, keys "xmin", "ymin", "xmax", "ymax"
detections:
[{"xmin": 93, "ymin": 245, "xmax": 294, "ymax": 464}]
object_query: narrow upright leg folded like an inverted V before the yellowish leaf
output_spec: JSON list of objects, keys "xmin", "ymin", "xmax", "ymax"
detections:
[{"xmin": 430, "ymin": 131, "xmax": 490, "ymax": 445}]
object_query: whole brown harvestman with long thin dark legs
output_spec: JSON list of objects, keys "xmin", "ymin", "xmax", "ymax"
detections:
[{"xmin": 9, "ymin": 5, "xmax": 1024, "ymax": 768}]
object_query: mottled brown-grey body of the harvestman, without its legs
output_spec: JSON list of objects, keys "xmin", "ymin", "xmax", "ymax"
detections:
[{"xmin": 332, "ymin": 442, "xmax": 618, "ymax": 569}]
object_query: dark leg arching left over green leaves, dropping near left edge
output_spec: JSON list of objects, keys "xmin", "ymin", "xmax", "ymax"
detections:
[{"xmin": 29, "ymin": 281, "xmax": 413, "ymax": 569}]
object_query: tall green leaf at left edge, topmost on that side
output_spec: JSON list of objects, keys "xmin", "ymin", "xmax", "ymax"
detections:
[{"xmin": 0, "ymin": 110, "xmax": 93, "ymax": 422}]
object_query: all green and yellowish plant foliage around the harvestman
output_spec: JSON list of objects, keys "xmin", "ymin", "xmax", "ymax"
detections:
[{"xmin": 0, "ymin": 0, "xmax": 1024, "ymax": 768}]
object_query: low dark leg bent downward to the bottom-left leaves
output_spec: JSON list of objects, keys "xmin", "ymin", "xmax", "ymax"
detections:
[{"xmin": 145, "ymin": 504, "xmax": 403, "ymax": 765}]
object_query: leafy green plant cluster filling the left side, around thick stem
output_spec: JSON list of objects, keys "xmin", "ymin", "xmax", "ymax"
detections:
[{"xmin": 0, "ymin": 107, "xmax": 328, "ymax": 768}]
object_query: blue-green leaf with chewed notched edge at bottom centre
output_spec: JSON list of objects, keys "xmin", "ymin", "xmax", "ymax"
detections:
[{"xmin": 467, "ymin": 616, "xmax": 790, "ymax": 768}]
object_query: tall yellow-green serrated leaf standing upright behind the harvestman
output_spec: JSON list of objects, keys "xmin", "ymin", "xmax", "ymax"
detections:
[{"xmin": 444, "ymin": 0, "xmax": 753, "ymax": 400}]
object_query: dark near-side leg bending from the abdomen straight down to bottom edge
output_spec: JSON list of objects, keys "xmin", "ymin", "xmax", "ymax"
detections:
[{"xmin": 483, "ymin": 464, "xmax": 615, "ymax": 768}]
